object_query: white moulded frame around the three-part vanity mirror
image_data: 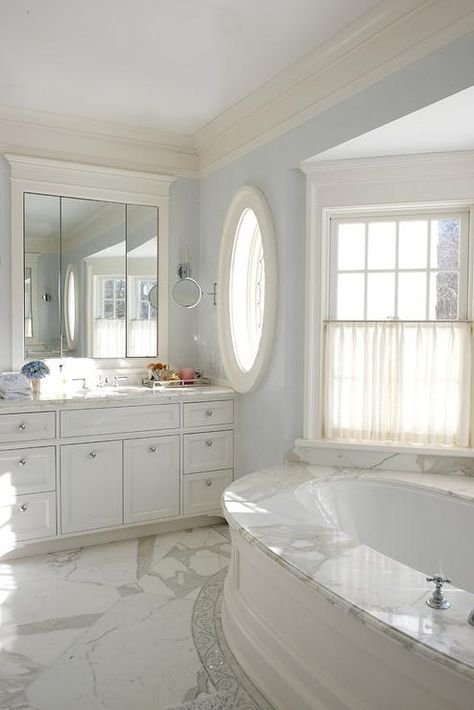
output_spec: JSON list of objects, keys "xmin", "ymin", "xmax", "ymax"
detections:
[{"xmin": 4, "ymin": 153, "xmax": 176, "ymax": 369}]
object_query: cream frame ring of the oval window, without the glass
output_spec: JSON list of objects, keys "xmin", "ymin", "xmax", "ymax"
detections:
[{"xmin": 217, "ymin": 185, "xmax": 278, "ymax": 392}]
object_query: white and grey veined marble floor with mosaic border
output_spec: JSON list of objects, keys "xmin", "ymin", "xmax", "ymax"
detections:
[{"xmin": 0, "ymin": 525, "xmax": 269, "ymax": 710}]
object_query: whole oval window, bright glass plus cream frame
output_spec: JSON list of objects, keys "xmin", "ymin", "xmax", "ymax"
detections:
[{"xmin": 218, "ymin": 187, "xmax": 277, "ymax": 392}]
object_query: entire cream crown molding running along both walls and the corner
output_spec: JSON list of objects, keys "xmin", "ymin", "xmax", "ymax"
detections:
[{"xmin": 0, "ymin": 0, "xmax": 474, "ymax": 177}]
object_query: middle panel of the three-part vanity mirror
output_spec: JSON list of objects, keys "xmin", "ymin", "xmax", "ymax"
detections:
[{"xmin": 61, "ymin": 198, "xmax": 126, "ymax": 358}]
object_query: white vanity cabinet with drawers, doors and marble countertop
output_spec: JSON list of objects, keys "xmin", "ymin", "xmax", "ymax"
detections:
[{"xmin": 0, "ymin": 386, "xmax": 236, "ymax": 556}]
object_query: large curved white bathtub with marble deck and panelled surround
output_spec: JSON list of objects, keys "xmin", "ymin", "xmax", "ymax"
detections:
[{"xmin": 223, "ymin": 465, "xmax": 474, "ymax": 710}]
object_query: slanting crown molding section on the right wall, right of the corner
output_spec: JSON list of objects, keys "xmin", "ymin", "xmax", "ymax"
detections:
[{"xmin": 195, "ymin": 0, "xmax": 474, "ymax": 174}]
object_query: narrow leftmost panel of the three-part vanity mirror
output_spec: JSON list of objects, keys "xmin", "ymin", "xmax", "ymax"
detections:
[{"xmin": 24, "ymin": 193, "xmax": 60, "ymax": 358}]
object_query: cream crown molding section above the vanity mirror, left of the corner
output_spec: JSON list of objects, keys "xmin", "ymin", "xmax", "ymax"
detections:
[{"xmin": 0, "ymin": 106, "xmax": 198, "ymax": 177}]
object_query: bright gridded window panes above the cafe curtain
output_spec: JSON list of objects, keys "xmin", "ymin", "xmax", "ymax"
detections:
[{"xmin": 329, "ymin": 212, "xmax": 468, "ymax": 320}]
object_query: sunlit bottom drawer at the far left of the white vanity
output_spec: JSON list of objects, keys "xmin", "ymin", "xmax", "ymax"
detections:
[{"xmin": 0, "ymin": 493, "xmax": 56, "ymax": 544}]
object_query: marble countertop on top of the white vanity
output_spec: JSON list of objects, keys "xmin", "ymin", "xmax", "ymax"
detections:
[{"xmin": 0, "ymin": 385, "xmax": 235, "ymax": 413}]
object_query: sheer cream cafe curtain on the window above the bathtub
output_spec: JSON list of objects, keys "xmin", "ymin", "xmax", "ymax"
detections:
[{"xmin": 324, "ymin": 321, "xmax": 471, "ymax": 446}]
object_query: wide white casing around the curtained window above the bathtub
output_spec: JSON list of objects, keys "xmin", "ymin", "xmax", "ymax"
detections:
[{"xmin": 302, "ymin": 151, "xmax": 474, "ymax": 455}]
